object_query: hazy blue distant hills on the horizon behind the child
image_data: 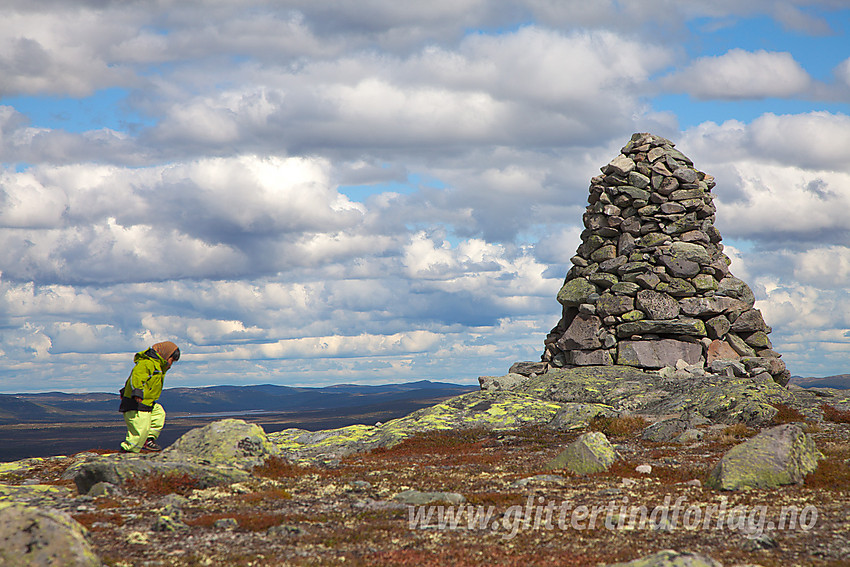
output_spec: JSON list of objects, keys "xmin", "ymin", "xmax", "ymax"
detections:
[{"xmin": 0, "ymin": 380, "xmax": 478, "ymax": 425}]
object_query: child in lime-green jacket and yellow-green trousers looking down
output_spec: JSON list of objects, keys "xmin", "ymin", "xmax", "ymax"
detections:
[{"xmin": 118, "ymin": 341, "xmax": 180, "ymax": 453}]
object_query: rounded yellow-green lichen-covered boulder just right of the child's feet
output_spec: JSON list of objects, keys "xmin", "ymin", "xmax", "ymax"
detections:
[{"xmin": 163, "ymin": 419, "xmax": 279, "ymax": 468}]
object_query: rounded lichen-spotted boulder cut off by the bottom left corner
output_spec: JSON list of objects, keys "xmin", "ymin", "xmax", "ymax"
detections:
[{"xmin": 0, "ymin": 504, "xmax": 101, "ymax": 567}]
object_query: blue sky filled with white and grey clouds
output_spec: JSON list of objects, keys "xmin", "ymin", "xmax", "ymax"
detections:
[{"xmin": 0, "ymin": 0, "xmax": 850, "ymax": 393}]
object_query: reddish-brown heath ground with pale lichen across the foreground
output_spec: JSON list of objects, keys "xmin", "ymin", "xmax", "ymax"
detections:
[{"xmin": 0, "ymin": 370, "xmax": 850, "ymax": 567}]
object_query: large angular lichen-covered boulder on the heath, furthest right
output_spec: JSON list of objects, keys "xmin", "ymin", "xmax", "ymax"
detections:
[{"xmin": 708, "ymin": 424, "xmax": 823, "ymax": 490}]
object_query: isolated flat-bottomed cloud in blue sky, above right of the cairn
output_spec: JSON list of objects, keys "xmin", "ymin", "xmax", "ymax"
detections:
[{"xmin": 663, "ymin": 48, "xmax": 811, "ymax": 100}]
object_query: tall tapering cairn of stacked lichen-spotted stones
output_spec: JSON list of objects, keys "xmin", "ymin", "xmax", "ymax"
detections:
[{"xmin": 542, "ymin": 133, "xmax": 790, "ymax": 385}]
